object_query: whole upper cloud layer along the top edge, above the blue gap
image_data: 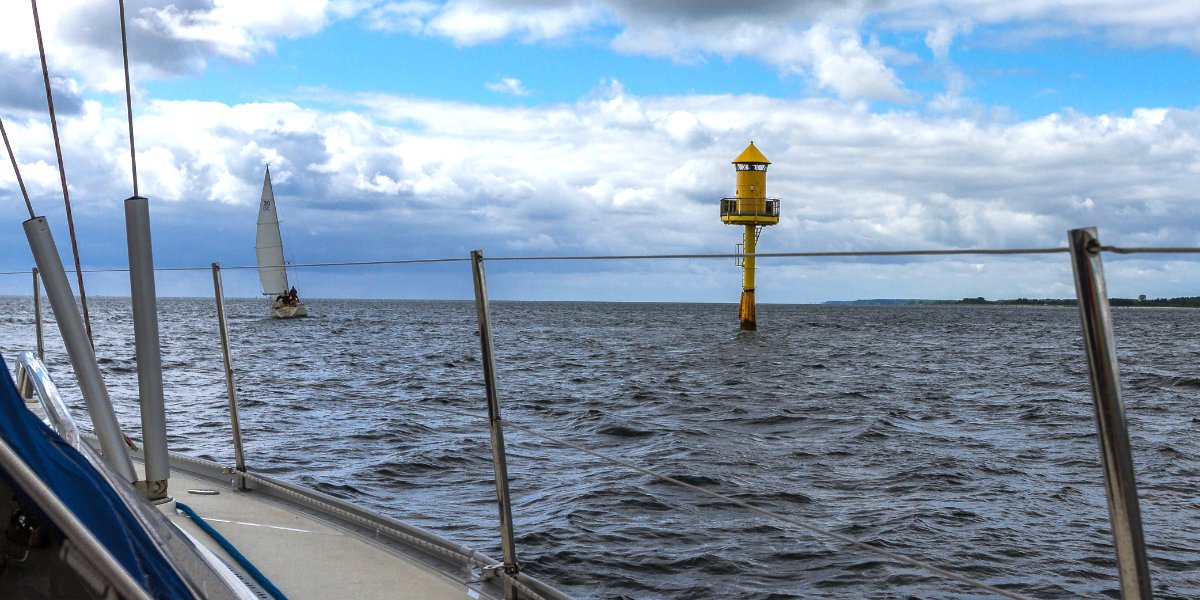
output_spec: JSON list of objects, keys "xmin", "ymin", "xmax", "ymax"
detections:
[{"xmin": 11, "ymin": 0, "xmax": 1200, "ymax": 102}]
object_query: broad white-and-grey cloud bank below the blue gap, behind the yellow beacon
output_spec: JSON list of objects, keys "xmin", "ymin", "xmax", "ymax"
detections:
[{"xmin": 0, "ymin": 82, "xmax": 1200, "ymax": 300}]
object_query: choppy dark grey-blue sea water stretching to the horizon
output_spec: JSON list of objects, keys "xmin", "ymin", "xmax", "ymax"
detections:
[{"xmin": 0, "ymin": 298, "xmax": 1200, "ymax": 599}]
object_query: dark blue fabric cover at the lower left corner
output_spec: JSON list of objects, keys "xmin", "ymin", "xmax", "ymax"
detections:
[{"xmin": 0, "ymin": 356, "xmax": 193, "ymax": 600}]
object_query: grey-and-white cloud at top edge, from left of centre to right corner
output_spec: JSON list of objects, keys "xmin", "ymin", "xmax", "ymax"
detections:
[{"xmin": 355, "ymin": 0, "xmax": 1200, "ymax": 103}]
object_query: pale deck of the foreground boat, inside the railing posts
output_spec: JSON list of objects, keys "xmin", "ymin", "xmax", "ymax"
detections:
[{"xmin": 14, "ymin": 353, "xmax": 570, "ymax": 600}]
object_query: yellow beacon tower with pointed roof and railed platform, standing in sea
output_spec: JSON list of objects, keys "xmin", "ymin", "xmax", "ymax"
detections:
[{"xmin": 721, "ymin": 142, "xmax": 779, "ymax": 330}]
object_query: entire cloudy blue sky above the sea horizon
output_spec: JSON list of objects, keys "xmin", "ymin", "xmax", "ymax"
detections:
[{"xmin": 0, "ymin": 0, "xmax": 1200, "ymax": 304}]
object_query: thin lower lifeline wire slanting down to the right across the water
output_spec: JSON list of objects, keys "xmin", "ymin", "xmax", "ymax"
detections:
[{"xmin": 381, "ymin": 396, "xmax": 1030, "ymax": 600}]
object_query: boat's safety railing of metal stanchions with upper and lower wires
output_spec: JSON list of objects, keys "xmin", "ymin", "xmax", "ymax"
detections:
[{"xmin": 9, "ymin": 225, "xmax": 1176, "ymax": 600}]
